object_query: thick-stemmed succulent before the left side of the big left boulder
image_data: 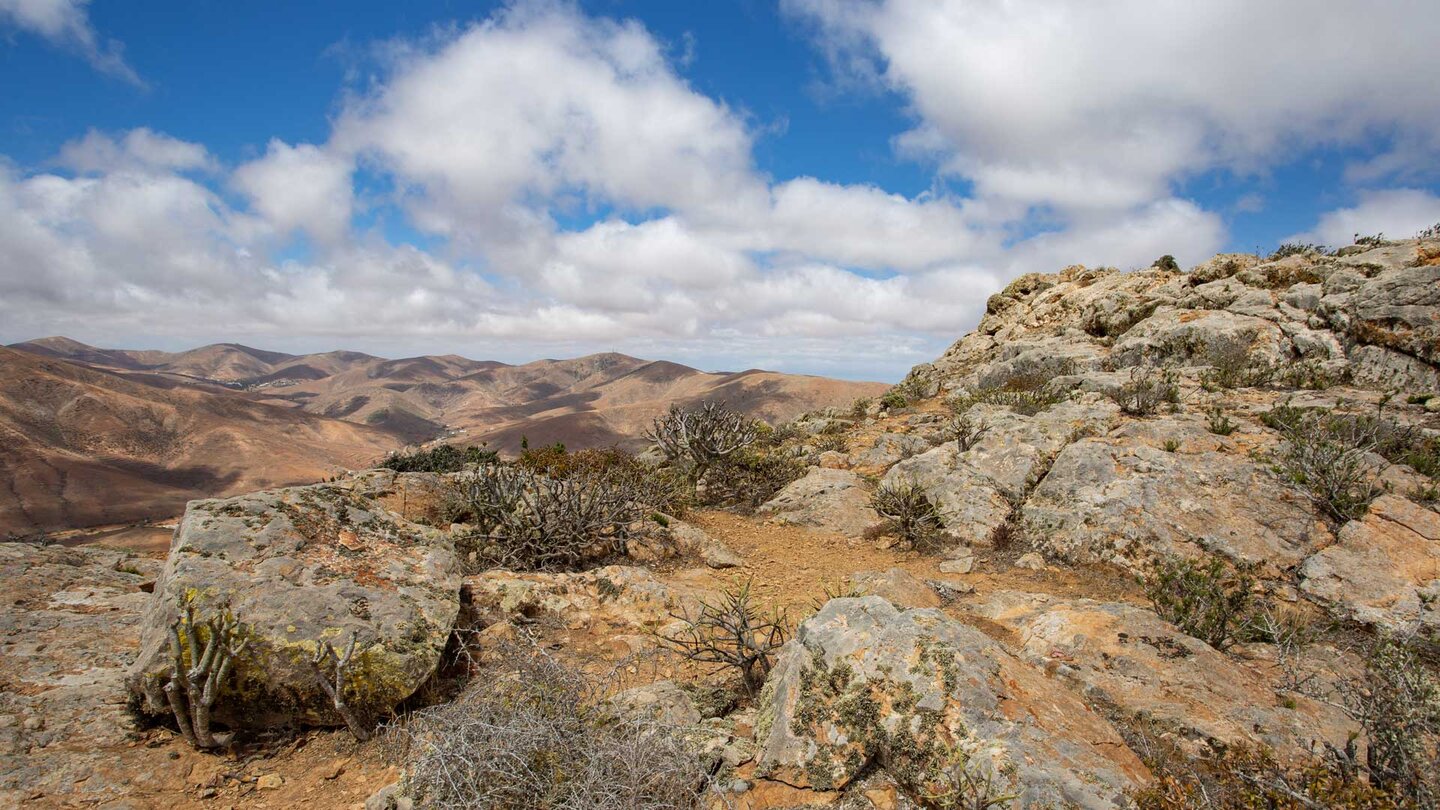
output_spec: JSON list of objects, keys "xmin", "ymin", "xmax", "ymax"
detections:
[{"xmin": 164, "ymin": 605, "xmax": 249, "ymax": 748}]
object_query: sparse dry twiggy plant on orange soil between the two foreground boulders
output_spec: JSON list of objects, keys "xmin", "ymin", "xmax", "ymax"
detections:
[{"xmin": 660, "ymin": 581, "xmax": 788, "ymax": 698}]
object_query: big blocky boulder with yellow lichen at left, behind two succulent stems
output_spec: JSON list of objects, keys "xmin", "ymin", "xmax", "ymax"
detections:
[{"xmin": 127, "ymin": 484, "xmax": 461, "ymax": 728}]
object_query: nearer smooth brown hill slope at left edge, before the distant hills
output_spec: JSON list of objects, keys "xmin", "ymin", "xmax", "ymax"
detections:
[{"xmin": 0, "ymin": 340, "xmax": 402, "ymax": 536}]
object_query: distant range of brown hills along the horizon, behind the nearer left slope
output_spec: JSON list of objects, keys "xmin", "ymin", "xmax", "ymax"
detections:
[{"xmin": 12, "ymin": 337, "xmax": 886, "ymax": 453}]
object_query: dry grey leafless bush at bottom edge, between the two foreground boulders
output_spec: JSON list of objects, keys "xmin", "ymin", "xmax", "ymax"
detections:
[{"xmin": 386, "ymin": 647, "xmax": 710, "ymax": 810}]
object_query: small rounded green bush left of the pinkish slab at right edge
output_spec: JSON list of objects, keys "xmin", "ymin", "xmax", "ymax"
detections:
[{"xmin": 1143, "ymin": 555, "xmax": 1257, "ymax": 651}]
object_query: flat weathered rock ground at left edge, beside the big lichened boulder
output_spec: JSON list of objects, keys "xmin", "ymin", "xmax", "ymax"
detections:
[{"xmin": 0, "ymin": 543, "xmax": 160, "ymax": 807}]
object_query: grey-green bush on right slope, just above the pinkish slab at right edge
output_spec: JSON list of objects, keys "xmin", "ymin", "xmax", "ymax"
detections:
[{"xmin": 1263, "ymin": 405, "xmax": 1384, "ymax": 520}]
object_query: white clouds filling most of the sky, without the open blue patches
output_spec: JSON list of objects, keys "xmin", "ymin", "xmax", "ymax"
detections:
[{"xmin": 0, "ymin": 0, "xmax": 1440, "ymax": 378}]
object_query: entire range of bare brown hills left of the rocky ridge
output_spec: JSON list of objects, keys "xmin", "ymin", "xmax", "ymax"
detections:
[{"xmin": 0, "ymin": 337, "xmax": 886, "ymax": 533}]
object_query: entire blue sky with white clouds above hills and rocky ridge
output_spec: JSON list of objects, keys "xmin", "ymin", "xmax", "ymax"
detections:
[{"xmin": 0, "ymin": 0, "xmax": 1440, "ymax": 379}]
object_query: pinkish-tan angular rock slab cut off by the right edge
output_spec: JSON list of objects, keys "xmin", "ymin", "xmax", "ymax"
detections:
[{"xmin": 1300, "ymin": 494, "xmax": 1440, "ymax": 630}]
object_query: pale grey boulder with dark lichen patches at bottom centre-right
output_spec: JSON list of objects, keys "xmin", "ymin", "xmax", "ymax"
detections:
[{"xmin": 756, "ymin": 597, "xmax": 1148, "ymax": 809}]
